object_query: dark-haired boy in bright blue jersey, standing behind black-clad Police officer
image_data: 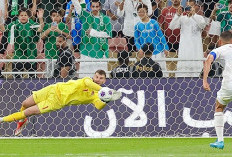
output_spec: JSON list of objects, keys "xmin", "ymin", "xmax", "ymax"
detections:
[{"xmin": 134, "ymin": 4, "xmax": 169, "ymax": 75}]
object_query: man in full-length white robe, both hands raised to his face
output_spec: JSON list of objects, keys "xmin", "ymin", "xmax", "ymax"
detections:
[{"xmin": 169, "ymin": 0, "xmax": 206, "ymax": 77}]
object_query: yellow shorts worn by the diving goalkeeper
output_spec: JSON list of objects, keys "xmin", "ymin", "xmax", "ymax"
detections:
[{"xmin": 32, "ymin": 85, "xmax": 63, "ymax": 114}]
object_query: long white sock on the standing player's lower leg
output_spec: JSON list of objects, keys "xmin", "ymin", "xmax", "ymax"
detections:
[{"xmin": 214, "ymin": 112, "xmax": 224, "ymax": 142}]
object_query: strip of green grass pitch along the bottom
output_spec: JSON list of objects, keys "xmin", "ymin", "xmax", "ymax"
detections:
[{"xmin": 0, "ymin": 138, "xmax": 232, "ymax": 157}]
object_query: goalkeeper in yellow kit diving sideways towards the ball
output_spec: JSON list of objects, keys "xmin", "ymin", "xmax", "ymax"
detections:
[{"xmin": 0, "ymin": 70, "xmax": 121, "ymax": 135}]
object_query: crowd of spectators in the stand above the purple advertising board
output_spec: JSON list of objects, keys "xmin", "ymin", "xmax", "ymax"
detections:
[{"xmin": 0, "ymin": 0, "xmax": 229, "ymax": 78}]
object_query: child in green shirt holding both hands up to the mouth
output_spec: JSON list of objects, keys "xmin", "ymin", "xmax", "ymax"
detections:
[{"xmin": 41, "ymin": 10, "xmax": 71, "ymax": 59}]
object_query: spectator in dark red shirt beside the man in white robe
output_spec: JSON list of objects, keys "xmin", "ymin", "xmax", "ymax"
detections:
[{"xmin": 159, "ymin": 0, "xmax": 181, "ymax": 77}]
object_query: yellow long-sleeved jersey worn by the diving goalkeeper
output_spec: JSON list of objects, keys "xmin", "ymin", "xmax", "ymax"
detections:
[{"xmin": 56, "ymin": 77, "xmax": 106, "ymax": 109}]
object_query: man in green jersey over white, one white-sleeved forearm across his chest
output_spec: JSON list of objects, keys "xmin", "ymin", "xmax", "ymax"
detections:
[{"xmin": 72, "ymin": 0, "xmax": 112, "ymax": 77}]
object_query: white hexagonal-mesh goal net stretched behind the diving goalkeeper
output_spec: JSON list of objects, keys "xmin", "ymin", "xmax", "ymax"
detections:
[{"xmin": 0, "ymin": 0, "xmax": 232, "ymax": 137}]
